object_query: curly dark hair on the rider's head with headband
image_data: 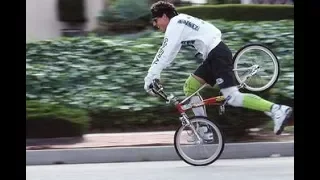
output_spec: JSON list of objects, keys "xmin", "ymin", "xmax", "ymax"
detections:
[{"xmin": 150, "ymin": 1, "xmax": 178, "ymax": 19}]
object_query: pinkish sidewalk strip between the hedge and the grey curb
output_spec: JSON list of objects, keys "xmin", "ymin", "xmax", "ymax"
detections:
[{"xmin": 26, "ymin": 131, "xmax": 294, "ymax": 150}]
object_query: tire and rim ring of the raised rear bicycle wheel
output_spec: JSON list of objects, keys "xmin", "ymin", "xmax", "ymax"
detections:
[{"xmin": 233, "ymin": 43, "xmax": 280, "ymax": 92}]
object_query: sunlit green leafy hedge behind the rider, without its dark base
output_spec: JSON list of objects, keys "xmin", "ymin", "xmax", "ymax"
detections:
[{"xmin": 26, "ymin": 21, "xmax": 294, "ymax": 110}]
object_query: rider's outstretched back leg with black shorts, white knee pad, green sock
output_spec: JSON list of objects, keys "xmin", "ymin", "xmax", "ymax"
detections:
[{"xmin": 208, "ymin": 43, "xmax": 292, "ymax": 134}]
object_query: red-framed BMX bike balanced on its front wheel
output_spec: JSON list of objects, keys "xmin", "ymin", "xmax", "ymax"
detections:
[{"xmin": 151, "ymin": 44, "xmax": 280, "ymax": 166}]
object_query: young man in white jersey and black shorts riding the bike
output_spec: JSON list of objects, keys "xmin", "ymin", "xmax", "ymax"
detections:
[{"xmin": 144, "ymin": 1, "xmax": 292, "ymax": 135}]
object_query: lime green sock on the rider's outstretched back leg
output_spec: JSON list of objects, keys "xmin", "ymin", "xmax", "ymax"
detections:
[{"xmin": 243, "ymin": 93, "xmax": 274, "ymax": 112}]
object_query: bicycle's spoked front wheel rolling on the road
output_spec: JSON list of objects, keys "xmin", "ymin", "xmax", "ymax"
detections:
[{"xmin": 174, "ymin": 116, "xmax": 225, "ymax": 166}]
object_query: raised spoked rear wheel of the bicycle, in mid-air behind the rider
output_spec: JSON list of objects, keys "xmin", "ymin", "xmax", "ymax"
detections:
[{"xmin": 233, "ymin": 44, "xmax": 280, "ymax": 92}]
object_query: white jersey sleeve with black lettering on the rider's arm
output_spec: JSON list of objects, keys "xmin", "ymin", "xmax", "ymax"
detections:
[{"xmin": 148, "ymin": 21, "xmax": 184, "ymax": 78}]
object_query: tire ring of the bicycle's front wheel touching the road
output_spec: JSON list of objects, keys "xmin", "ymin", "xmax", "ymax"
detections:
[{"xmin": 174, "ymin": 116, "xmax": 225, "ymax": 166}]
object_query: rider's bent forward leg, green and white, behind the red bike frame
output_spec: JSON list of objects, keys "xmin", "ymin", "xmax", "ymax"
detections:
[{"xmin": 183, "ymin": 74, "xmax": 207, "ymax": 116}]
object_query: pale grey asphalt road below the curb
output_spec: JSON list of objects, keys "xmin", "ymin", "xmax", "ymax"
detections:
[{"xmin": 26, "ymin": 157, "xmax": 294, "ymax": 180}]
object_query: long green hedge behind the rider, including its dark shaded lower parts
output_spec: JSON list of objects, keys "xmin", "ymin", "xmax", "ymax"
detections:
[{"xmin": 26, "ymin": 20, "xmax": 294, "ymax": 140}]
